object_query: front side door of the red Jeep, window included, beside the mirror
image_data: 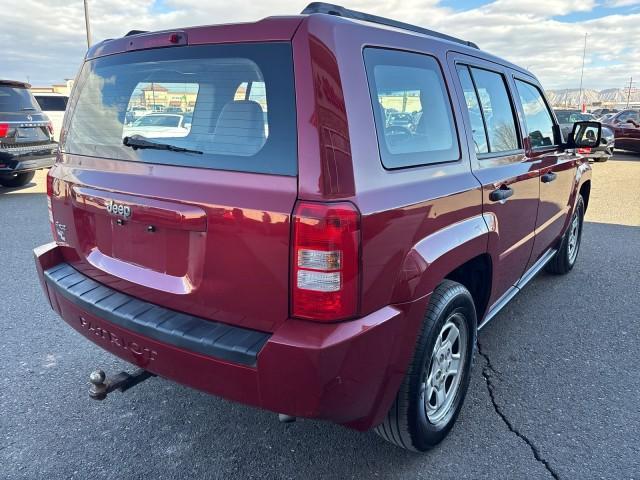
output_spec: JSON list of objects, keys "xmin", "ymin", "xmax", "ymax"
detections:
[{"xmin": 514, "ymin": 77, "xmax": 579, "ymax": 267}]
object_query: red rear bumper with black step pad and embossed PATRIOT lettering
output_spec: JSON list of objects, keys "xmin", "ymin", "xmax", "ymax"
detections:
[{"xmin": 34, "ymin": 244, "xmax": 428, "ymax": 430}]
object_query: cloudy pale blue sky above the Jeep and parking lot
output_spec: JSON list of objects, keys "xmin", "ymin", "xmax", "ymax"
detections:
[{"xmin": 0, "ymin": 0, "xmax": 640, "ymax": 90}]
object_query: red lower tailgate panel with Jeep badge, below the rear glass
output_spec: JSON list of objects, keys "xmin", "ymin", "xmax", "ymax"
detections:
[{"xmin": 51, "ymin": 161, "xmax": 297, "ymax": 332}]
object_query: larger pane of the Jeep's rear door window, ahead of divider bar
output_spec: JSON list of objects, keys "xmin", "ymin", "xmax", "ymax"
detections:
[{"xmin": 471, "ymin": 67, "xmax": 520, "ymax": 153}]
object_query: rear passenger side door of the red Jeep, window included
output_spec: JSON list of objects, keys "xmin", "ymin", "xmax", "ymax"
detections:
[{"xmin": 450, "ymin": 54, "xmax": 539, "ymax": 305}]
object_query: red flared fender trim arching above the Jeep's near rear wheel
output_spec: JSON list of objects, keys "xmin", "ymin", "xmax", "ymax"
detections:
[{"xmin": 392, "ymin": 213, "xmax": 497, "ymax": 303}]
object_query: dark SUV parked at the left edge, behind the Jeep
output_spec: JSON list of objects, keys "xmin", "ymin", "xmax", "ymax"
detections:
[{"xmin": 0, "ymin": 80, "xmax": 58, "ymax": 187}]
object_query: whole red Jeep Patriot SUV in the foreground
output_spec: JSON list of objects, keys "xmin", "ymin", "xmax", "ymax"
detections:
[{"xmin": 35, "ymin": 3, "xmax": 601, "ymax": 450}]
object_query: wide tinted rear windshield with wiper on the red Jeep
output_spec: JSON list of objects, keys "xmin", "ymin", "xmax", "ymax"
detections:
[{"xmin": 62, "ymin": 43, "xmax": 297, "ymax": 175}]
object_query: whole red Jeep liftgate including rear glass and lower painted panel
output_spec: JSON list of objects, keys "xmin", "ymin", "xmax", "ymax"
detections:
[{"xmin": 52, "ymin": 42, "xmax": 297, "ymax": 331}]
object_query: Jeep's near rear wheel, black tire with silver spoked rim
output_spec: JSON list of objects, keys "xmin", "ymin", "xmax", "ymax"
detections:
[{"xmin": 375, "ymin": 280, "xmax": 476, "ymax": 452}]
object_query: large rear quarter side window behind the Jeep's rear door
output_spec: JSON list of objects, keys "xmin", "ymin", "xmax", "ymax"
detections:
[{"xmin": 364, "ymin": 48, "xmax": 460, "ymax": 169}]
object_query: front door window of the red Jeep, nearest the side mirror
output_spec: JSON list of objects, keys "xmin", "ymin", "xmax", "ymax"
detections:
[{"xmin": 516, "ymin": 80, "xmax": 556, "ymax": 148}]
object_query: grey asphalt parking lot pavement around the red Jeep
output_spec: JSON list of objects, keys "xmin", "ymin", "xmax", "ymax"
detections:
[{"xmin": 0, "ymin": 154, "xmax": 640, "ymax": 480}]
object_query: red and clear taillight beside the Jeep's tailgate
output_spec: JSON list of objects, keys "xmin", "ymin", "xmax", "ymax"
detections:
[{"xmin": 291, "ymin": 202, "xmax": 360, "ymax": 322}]
